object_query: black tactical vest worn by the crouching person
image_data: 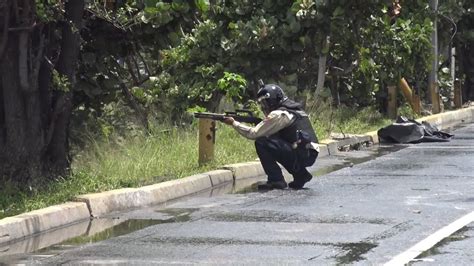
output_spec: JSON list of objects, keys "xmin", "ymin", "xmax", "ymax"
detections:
[{"xmin": 276, "ymin": 107, "xmax": 318, "ymax": 147}]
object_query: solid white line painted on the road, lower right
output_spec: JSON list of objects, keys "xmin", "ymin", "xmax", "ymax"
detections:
[{"xmin": 384, "ymin": 211, "xmax": 474, "ymax": 266}]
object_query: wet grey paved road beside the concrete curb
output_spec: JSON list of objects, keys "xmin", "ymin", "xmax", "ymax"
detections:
[{"xmin": 0, "ymin": 124, "xmax": 474, "ymax": 265}]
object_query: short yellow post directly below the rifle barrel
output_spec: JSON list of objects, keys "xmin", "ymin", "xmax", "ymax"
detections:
[{"xmin": 199, "ymin": 118, "xmax": 216, "ymax": 165}]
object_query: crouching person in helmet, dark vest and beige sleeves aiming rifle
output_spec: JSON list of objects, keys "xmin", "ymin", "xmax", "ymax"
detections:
[{"xmin": 232, "ymin": 84, "xmax": 319, "ymax": 189}]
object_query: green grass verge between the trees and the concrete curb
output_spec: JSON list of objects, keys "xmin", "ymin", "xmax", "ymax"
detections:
[{"xmin": 0, "ymin": 105, "xmax": 390, "ymax": 218}]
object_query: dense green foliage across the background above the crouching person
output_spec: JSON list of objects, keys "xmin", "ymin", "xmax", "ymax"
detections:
[{"xmin": 74, "ymin": 0, "xmax": 474, "ymax": 121}]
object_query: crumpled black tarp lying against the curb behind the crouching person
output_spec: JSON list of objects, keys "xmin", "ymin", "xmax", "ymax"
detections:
[{"xmin": 377, "ymin": 116, "xmax": 454, "ymax": 143}]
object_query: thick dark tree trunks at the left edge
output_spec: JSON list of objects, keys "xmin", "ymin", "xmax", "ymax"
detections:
[{"xmin": 0, "ymin": 0, "xmax": 84, "ymax": 186}]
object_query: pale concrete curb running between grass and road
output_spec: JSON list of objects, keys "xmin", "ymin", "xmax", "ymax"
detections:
[{"xmin": 0, "ymin": 107, "xmax": 474, "ymax": 244}]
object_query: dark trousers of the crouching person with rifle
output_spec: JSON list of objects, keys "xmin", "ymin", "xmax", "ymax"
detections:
[{"xmin": 255, "ymin": 137, "xmax": 318, "ymax": 183}]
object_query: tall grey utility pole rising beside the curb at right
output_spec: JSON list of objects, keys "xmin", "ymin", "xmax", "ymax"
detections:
[{"xmin": 428, "ymin": 0, "xmax": 441, "ymax": 114}]
